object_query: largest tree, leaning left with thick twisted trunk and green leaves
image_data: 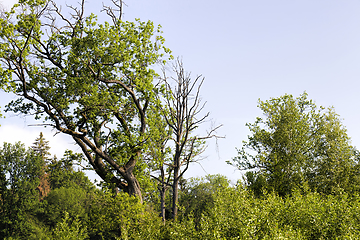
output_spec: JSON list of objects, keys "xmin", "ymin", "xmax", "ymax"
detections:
[{"xmin": 0, "ymin": 0, "xmax": 169, "ymax": 202}]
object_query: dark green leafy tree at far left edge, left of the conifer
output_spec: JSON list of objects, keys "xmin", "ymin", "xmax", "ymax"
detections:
[{"xmin": 0, "ymin": 142, "xmax": 43, "ymax": 238}]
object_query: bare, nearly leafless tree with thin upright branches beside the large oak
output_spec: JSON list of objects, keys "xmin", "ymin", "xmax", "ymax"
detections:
[{"xmin": 152, "ymin": 59, "xmax": 221, "ymax": 219}]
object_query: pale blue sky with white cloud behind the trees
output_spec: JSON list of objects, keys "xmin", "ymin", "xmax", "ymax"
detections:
[{"xmin": 0, "ymin": 0, "xmax": 360, "ymax": 182}]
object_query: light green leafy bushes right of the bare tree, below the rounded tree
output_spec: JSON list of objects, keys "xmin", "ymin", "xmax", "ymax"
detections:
[{"xmin": 195, "ymin": 187, "xmax": 360, "ymax": 239}]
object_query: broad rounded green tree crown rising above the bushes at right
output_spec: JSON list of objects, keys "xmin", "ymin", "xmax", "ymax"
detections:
[{"xmin": 229, "ymin": 93, "xmax": 357, "ymax": 196}]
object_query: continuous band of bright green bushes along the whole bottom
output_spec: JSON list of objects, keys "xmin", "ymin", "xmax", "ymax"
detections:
[{"xmin": 3, "ymin": 171, "xmax": 360, "ymax": 240}]
